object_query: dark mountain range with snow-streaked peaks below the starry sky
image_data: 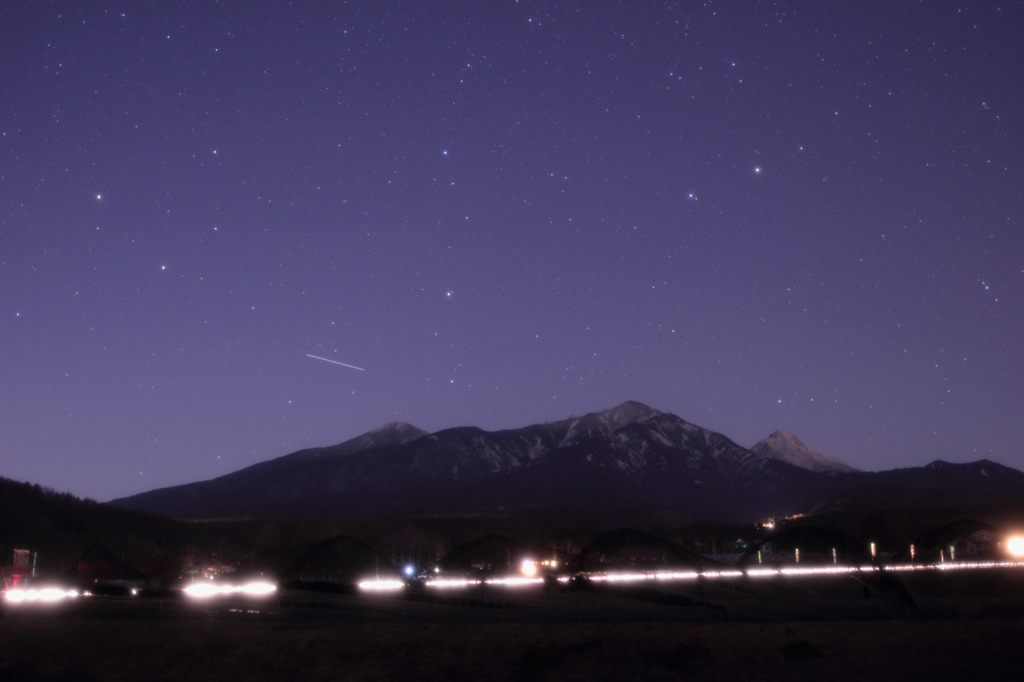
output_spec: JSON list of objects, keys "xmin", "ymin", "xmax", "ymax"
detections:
[{"xmin": 110, "ymin": 401, "xmax": 1024, "ymax": 521}]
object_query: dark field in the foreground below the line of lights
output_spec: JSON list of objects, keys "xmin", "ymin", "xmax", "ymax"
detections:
[{"xmin": 6, "ymin": 571, "xmax": 1024, "ymax": 681}]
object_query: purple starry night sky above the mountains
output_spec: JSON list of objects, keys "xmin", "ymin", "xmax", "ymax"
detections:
[{"xmin": 0, "ymin": 0, "xmax": 1024, "ymax": 500}]
